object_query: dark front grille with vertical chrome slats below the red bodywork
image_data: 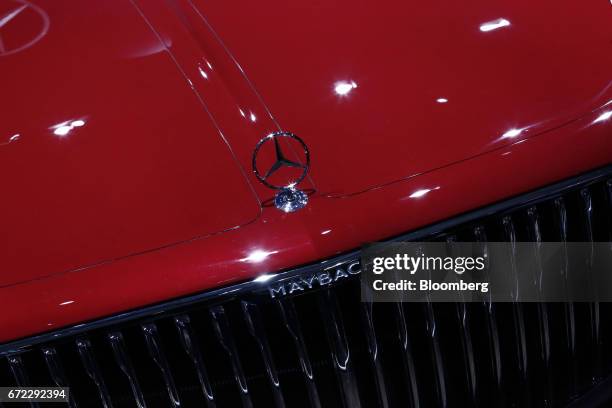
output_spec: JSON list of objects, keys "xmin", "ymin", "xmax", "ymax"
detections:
[{"xmin": 0, "ymin": 168, "xmax": 612, "ymax": 408}]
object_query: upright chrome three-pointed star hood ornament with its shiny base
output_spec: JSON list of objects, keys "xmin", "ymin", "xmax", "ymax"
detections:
[{"xmin": 253, "ymin": 132, "xmax": 310, "ymax": 212}]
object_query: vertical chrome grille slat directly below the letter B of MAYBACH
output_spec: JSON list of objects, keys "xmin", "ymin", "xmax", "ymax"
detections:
[{"xmin": 317, "ymin": 290, "xmax": 361, "ymax": 408}]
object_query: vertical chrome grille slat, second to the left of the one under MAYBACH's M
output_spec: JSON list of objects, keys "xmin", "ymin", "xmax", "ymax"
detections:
[{"xmin": 210, "ymin": 306, "xmax": 253, "ymax": 408}]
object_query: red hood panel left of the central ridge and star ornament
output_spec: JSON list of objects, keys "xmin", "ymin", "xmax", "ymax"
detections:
[{"xmin": 0, "ymin": 0, "xmax": 260, "ymax": 287}]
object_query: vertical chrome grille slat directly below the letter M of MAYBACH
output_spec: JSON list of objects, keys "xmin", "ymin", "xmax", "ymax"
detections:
[{"xmin": 277, "ymin": 299, "xmax": 321, "ymax": 408}]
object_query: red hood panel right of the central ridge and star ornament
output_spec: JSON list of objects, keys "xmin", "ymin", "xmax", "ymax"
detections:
[{"xmin": 195, "ymin": 0, "xmax": 612, "ymax": 195}]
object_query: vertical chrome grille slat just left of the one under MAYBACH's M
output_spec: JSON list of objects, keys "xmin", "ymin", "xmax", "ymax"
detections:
[{"xmin": 241, "ymin": 301, "xmax": 285, "ymax": 408}]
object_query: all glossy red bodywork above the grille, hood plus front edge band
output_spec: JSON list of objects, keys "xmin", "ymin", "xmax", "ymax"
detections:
[{"xmin": 0, "ymin": 0, "xmax": 612, "ymax": 341}]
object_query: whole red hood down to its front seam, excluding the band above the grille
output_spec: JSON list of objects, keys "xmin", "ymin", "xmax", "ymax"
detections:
[{"xmin": 0, "ymin": 0, "xmax": 612, "ymax": 286}]
